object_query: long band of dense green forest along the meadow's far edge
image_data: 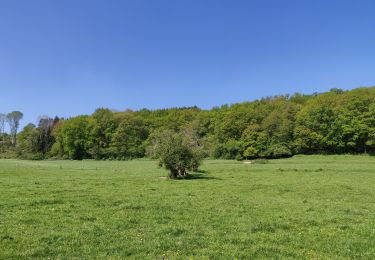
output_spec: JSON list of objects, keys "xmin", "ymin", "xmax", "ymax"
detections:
[{"xmin": 0, "ymin": 87, "xmax": 375, "ymax": 160}]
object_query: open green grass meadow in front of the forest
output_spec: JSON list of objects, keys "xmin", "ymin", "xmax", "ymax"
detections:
[{"xmin": 0, "ymin": 156, "xmax": 375, "ymax": 259}]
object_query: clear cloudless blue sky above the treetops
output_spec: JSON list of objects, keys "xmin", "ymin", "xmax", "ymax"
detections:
[{"xmin": 0, "ymin": 0, "xmax": 375, "ymax": 127}]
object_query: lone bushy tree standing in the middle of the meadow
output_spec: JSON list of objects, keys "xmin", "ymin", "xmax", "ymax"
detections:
[{"xmin": 148, "ymin": 130, "xmax": 204, "ymax": 179}]
